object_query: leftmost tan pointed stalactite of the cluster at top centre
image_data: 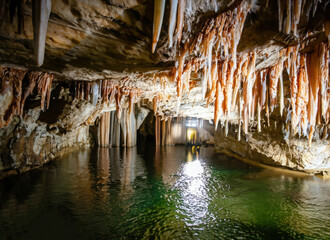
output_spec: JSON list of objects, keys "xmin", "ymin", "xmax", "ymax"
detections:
[{"xmin": 151, "ymin": 0, "xmax": 166, "ymax": 53}]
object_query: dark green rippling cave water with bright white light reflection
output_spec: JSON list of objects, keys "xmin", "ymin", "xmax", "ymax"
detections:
[{"xmin": 0, "ymin": 145, "xmax": 330, "ymax": 239}]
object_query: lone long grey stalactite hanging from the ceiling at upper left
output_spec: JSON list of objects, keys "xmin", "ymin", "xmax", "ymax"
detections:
[{"xmin": 32, "ymin": 0, "xmax": 51, "ymax": 67}]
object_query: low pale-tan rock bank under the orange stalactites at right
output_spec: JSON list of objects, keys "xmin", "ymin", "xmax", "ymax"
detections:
[{"xmin": 215, "ymin": 121, "xmax": 330, "ymax": 174}]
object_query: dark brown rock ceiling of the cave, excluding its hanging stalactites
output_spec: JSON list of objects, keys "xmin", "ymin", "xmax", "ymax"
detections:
[{"xmin": 0, "ymin": 0, "xmax": 330, "ymax": 119}]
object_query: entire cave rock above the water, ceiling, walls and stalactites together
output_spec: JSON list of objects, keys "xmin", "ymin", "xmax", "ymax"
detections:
[{"xmin": 0, "ymin": 0, "xmax": 330, "ymax": 176}]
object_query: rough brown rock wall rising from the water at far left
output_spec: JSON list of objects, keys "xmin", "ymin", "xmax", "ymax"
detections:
[{"xmin": 0, "ymin": 105, "xmax": 91, "ymax": 177}]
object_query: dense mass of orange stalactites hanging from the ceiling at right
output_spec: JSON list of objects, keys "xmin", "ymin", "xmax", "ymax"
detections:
[{"xmin": 153, "ymin": 0, "xmax": 329, "ymax": 143}]
